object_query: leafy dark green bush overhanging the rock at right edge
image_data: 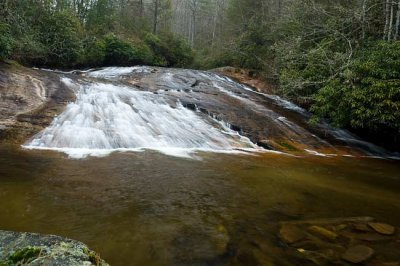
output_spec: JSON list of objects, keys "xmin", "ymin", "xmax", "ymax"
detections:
[{"xmin": 312, "ymin": 41, "xmax": 400, "ymax": 135}]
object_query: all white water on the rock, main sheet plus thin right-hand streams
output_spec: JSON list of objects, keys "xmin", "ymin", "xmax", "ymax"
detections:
[{"xmin": 24, "ymin": 66, "xmax": 394, "ymax": 158}]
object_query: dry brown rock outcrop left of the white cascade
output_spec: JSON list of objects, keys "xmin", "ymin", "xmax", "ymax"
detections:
[{"xmin": 0, "ymin": 62, "xmax": 75, "ymax": 143}]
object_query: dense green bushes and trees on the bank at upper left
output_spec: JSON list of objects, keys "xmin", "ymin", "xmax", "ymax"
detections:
[{"xmin": 0, "ymin": 0, "xmax": 193, "ymax": 68}]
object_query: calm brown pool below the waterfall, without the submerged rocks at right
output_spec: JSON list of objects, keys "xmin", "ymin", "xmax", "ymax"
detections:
[{"xmin": 0, "ymin": 146, "xmax": 400, "ymax": 265}]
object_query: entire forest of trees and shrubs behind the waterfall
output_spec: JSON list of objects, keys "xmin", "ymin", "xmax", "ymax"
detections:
[{"xmin": 0, "ymin": 0, "xmax": 400, "ymax": 150}]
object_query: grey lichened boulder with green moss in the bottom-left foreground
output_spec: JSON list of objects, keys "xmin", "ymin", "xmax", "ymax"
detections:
[{"xmin": 0, "ymin": 231, "xmax": 108, "ymax": 266}]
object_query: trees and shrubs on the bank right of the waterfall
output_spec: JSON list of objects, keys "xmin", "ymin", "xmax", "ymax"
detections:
[{"xmin": 192, "ymin": 0, "xmax": 400, "ymax": 150}]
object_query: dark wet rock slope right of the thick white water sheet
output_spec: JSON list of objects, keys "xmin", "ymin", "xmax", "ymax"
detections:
[{"xmin": 115, "ymin": 67, "xmax": 384, "ymax": 155}]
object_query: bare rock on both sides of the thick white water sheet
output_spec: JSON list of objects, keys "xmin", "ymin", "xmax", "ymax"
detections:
[{"xmin": 0, "ymin": 64, "xmax": 385, "ymax": 155}]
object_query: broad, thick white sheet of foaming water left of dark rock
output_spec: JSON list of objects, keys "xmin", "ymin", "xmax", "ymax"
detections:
[{"xmin": 24, "ymin": 72, "xmax": 258, "ymax": 158}]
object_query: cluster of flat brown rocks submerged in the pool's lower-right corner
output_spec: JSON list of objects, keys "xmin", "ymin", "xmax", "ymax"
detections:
[{"xmin": 279, "ymin": 217, "xmax": 400, "ymax": 266}]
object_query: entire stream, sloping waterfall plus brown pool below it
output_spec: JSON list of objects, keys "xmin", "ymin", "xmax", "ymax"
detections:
[{"xmin": 0, "ymin": 67, "xmax": 400, "ymax": 265}]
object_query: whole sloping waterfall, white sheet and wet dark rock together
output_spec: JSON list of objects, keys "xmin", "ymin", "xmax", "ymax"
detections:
[{"xmin": 24, "ymin": 66, "xmax": 391, "ymax": 158}]
